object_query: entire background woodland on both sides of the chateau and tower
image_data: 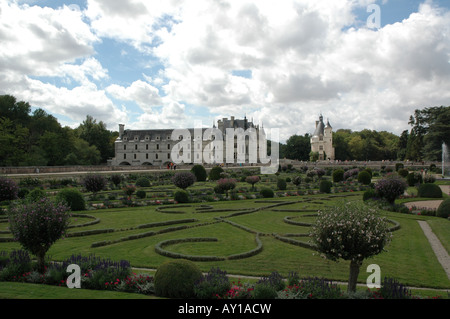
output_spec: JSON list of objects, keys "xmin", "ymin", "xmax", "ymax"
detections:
[{"xmin": 0, "ymin": 95, "xmax": 450, "ymax": 166}]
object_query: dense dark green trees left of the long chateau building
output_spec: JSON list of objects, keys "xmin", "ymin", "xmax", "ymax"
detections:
[{"xmin": 0, "ymin": 95, "xmax": 118, "ymax": 166}]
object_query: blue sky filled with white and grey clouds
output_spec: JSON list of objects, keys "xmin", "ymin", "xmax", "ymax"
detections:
[{"xmin": 0, "ymin": 0, "xmax": 450, "ymax": 142}]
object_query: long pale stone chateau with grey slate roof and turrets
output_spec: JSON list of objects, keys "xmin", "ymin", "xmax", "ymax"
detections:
[{"xmin": 110, "ymin": 116, "xmax": 264, "ymax": 167}]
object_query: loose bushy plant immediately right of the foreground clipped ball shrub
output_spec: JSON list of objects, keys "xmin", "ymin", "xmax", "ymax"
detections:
[{"xmin": 194, "ymin": 268, "xmax": 230, "ymax": 299}]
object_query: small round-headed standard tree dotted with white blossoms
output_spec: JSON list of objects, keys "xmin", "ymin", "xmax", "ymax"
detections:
[{"xmin": 310, "ymin": 202, "xmax": 391, "ymax": 292}]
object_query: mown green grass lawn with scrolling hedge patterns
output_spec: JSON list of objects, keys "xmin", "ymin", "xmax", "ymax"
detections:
[{"xmin": 0, "ymin": 172, "xmax": 450, "ymax": 299}]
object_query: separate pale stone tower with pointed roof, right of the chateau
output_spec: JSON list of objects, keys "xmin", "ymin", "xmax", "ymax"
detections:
[{"xmin": 311, "ymin": 115, "xmax": 334, "ymax": 161}]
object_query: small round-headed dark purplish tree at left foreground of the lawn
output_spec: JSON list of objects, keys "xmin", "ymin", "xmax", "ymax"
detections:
[{"xmin": 8, "ymin": 198, "xmax": 70, "ymax": 273}]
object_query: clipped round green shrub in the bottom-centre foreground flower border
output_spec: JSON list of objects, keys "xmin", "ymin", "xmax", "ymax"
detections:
[{"xmin": 154, "ymin": 259, "xmax": 203, "ymax": 299}]
